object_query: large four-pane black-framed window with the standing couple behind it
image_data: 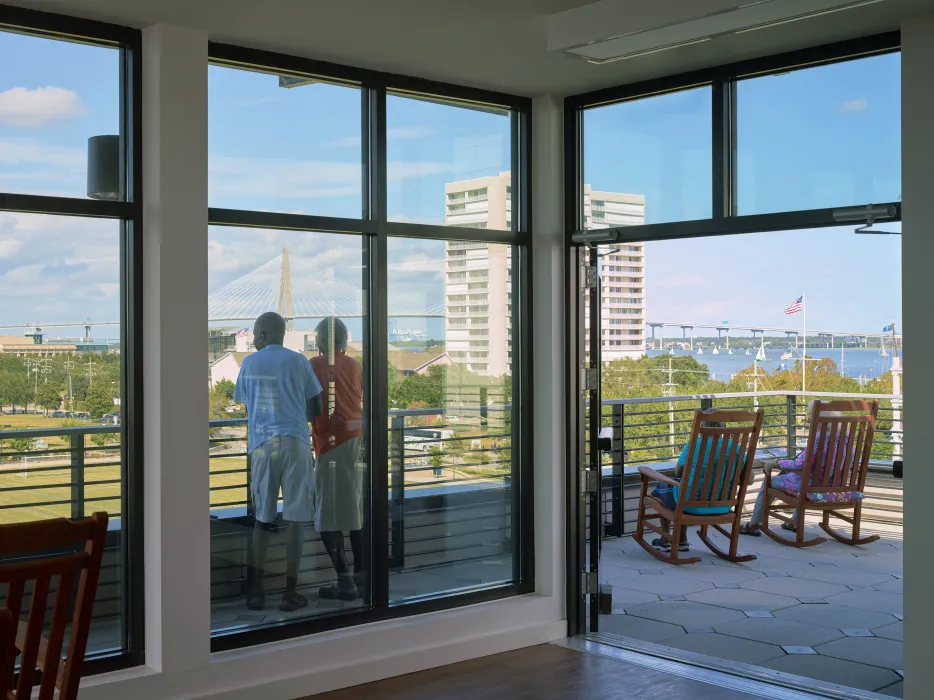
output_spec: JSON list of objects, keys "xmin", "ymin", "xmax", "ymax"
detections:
[{"xmin": 207, "ymin": 45, "xmax": 531, "ymax": 650}]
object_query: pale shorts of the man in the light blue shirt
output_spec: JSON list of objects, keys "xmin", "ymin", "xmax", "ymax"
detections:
[{"xmin": 250, "ymin": 436, "xmax": 314, "ymax": 523}]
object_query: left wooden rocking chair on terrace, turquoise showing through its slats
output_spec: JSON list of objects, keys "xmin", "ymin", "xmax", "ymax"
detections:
[{"xmin": 633, "ymin": 410, "xmax": 764, "ymax": 564}]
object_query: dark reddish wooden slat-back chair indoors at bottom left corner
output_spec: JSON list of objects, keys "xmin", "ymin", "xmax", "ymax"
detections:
[{"xmin": 0, "ymin": 513, "xmax": 107, "ymax": 700}]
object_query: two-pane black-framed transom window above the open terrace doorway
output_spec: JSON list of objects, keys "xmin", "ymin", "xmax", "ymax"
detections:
[{"xmin": 576, "ymin": 35, "xmax": 901, "ymax": 241}]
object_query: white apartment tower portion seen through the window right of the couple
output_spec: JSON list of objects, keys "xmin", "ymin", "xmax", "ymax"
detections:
[{"xmin": 444, "ymin": 172, "xmax": 512, "ymax": 377}]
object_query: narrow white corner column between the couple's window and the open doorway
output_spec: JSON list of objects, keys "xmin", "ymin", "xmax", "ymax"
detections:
[{"xmin": 532, "ymin": 95, "xmax": 568, "ymax": 610}]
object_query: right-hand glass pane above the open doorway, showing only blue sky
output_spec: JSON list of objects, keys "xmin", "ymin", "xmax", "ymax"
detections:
[{"xmin": 736, "ymin": 53, "xmax": 901, "ymax": 215}]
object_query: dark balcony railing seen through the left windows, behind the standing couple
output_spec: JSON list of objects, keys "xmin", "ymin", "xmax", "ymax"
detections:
[{"xmin": 0, "ymin": 405, "xmax": 513, "ymax": 617}]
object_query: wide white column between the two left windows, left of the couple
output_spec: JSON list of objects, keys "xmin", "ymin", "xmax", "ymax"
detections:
[{"xmin": 143, "ymin": 25, "xmax": 211, "ymax": 674}]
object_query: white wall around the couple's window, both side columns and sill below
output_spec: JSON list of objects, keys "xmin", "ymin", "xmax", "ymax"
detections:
[{"xmin": 81, "ymin": 25, "xmax": 567, "ymax": 700}]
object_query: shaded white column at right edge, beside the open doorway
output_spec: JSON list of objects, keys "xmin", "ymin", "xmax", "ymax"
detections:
[{"xmin": 902, "ymin": 16, "xmax": 934, "ymax": 698}]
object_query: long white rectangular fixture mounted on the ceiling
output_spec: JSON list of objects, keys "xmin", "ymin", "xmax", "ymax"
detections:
[{"xmin": 548, "ymin": 0, "xmax": 884, "ymax": 64}]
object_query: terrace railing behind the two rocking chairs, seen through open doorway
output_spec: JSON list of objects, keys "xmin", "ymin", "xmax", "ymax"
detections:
[{"xmin": 588, "ymin": 391, "xmax": 904, "ymax": 537}]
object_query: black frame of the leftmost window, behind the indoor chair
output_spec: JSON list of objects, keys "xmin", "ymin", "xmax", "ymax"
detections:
[{"xmin": 0, "ymin": 5, "xmax": 145, "ymax": 675}]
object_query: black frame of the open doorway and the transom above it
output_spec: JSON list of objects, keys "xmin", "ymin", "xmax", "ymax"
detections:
[{"xmin": 564, "ymin": 31, "xmax": 902, "ymax": 636}]
